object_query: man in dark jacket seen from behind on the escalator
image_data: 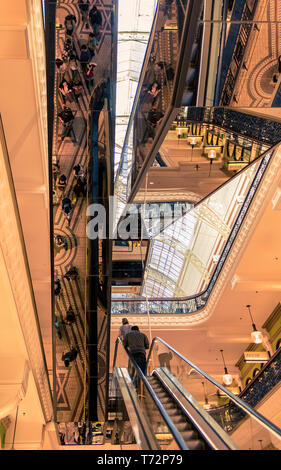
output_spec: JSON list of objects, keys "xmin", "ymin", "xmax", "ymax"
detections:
[{"xmin": 123, "ymin": 326, "xmax": 149, "ymax": 374}]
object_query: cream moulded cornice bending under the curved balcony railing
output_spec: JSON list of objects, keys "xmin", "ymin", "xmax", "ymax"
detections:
[{"xmin": 111, "ymin": 145, "xmax": 281, "ymax": 328}]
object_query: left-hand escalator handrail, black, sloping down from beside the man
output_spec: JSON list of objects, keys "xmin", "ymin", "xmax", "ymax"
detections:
[{"xmin": 113, "ymin": 337, "xmax": 189, "ymax": 450}]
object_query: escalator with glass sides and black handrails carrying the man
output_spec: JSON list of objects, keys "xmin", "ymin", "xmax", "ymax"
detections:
[{"xmin": 110, "ymin": 338, "xmax": 281, "ymax": 451}]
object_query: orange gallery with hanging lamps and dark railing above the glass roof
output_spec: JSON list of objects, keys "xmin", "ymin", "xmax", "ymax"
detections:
[{"xmin": 134, "ymin": 107, "xmax": 281, "ymax": 204}]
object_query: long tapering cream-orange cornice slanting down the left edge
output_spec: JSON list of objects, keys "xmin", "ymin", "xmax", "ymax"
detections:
[{"xmin": 0, "ymin": 117, "xmax": 53, "ymax": 422}]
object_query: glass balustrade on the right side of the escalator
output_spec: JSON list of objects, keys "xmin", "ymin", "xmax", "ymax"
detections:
[{"xmin": 147, "ymin": 338, "xmax": 281, "ymax": 450}]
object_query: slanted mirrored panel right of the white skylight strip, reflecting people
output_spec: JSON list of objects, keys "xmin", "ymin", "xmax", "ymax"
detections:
[{"xmin": 131, "ymin": 0, "xmax": 199, "ymax": 185}]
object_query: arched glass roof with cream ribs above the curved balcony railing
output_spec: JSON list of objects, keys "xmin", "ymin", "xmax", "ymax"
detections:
[{"xmin": 142, "ymin": 158, "xmax": 259, "ymax": 298}]
